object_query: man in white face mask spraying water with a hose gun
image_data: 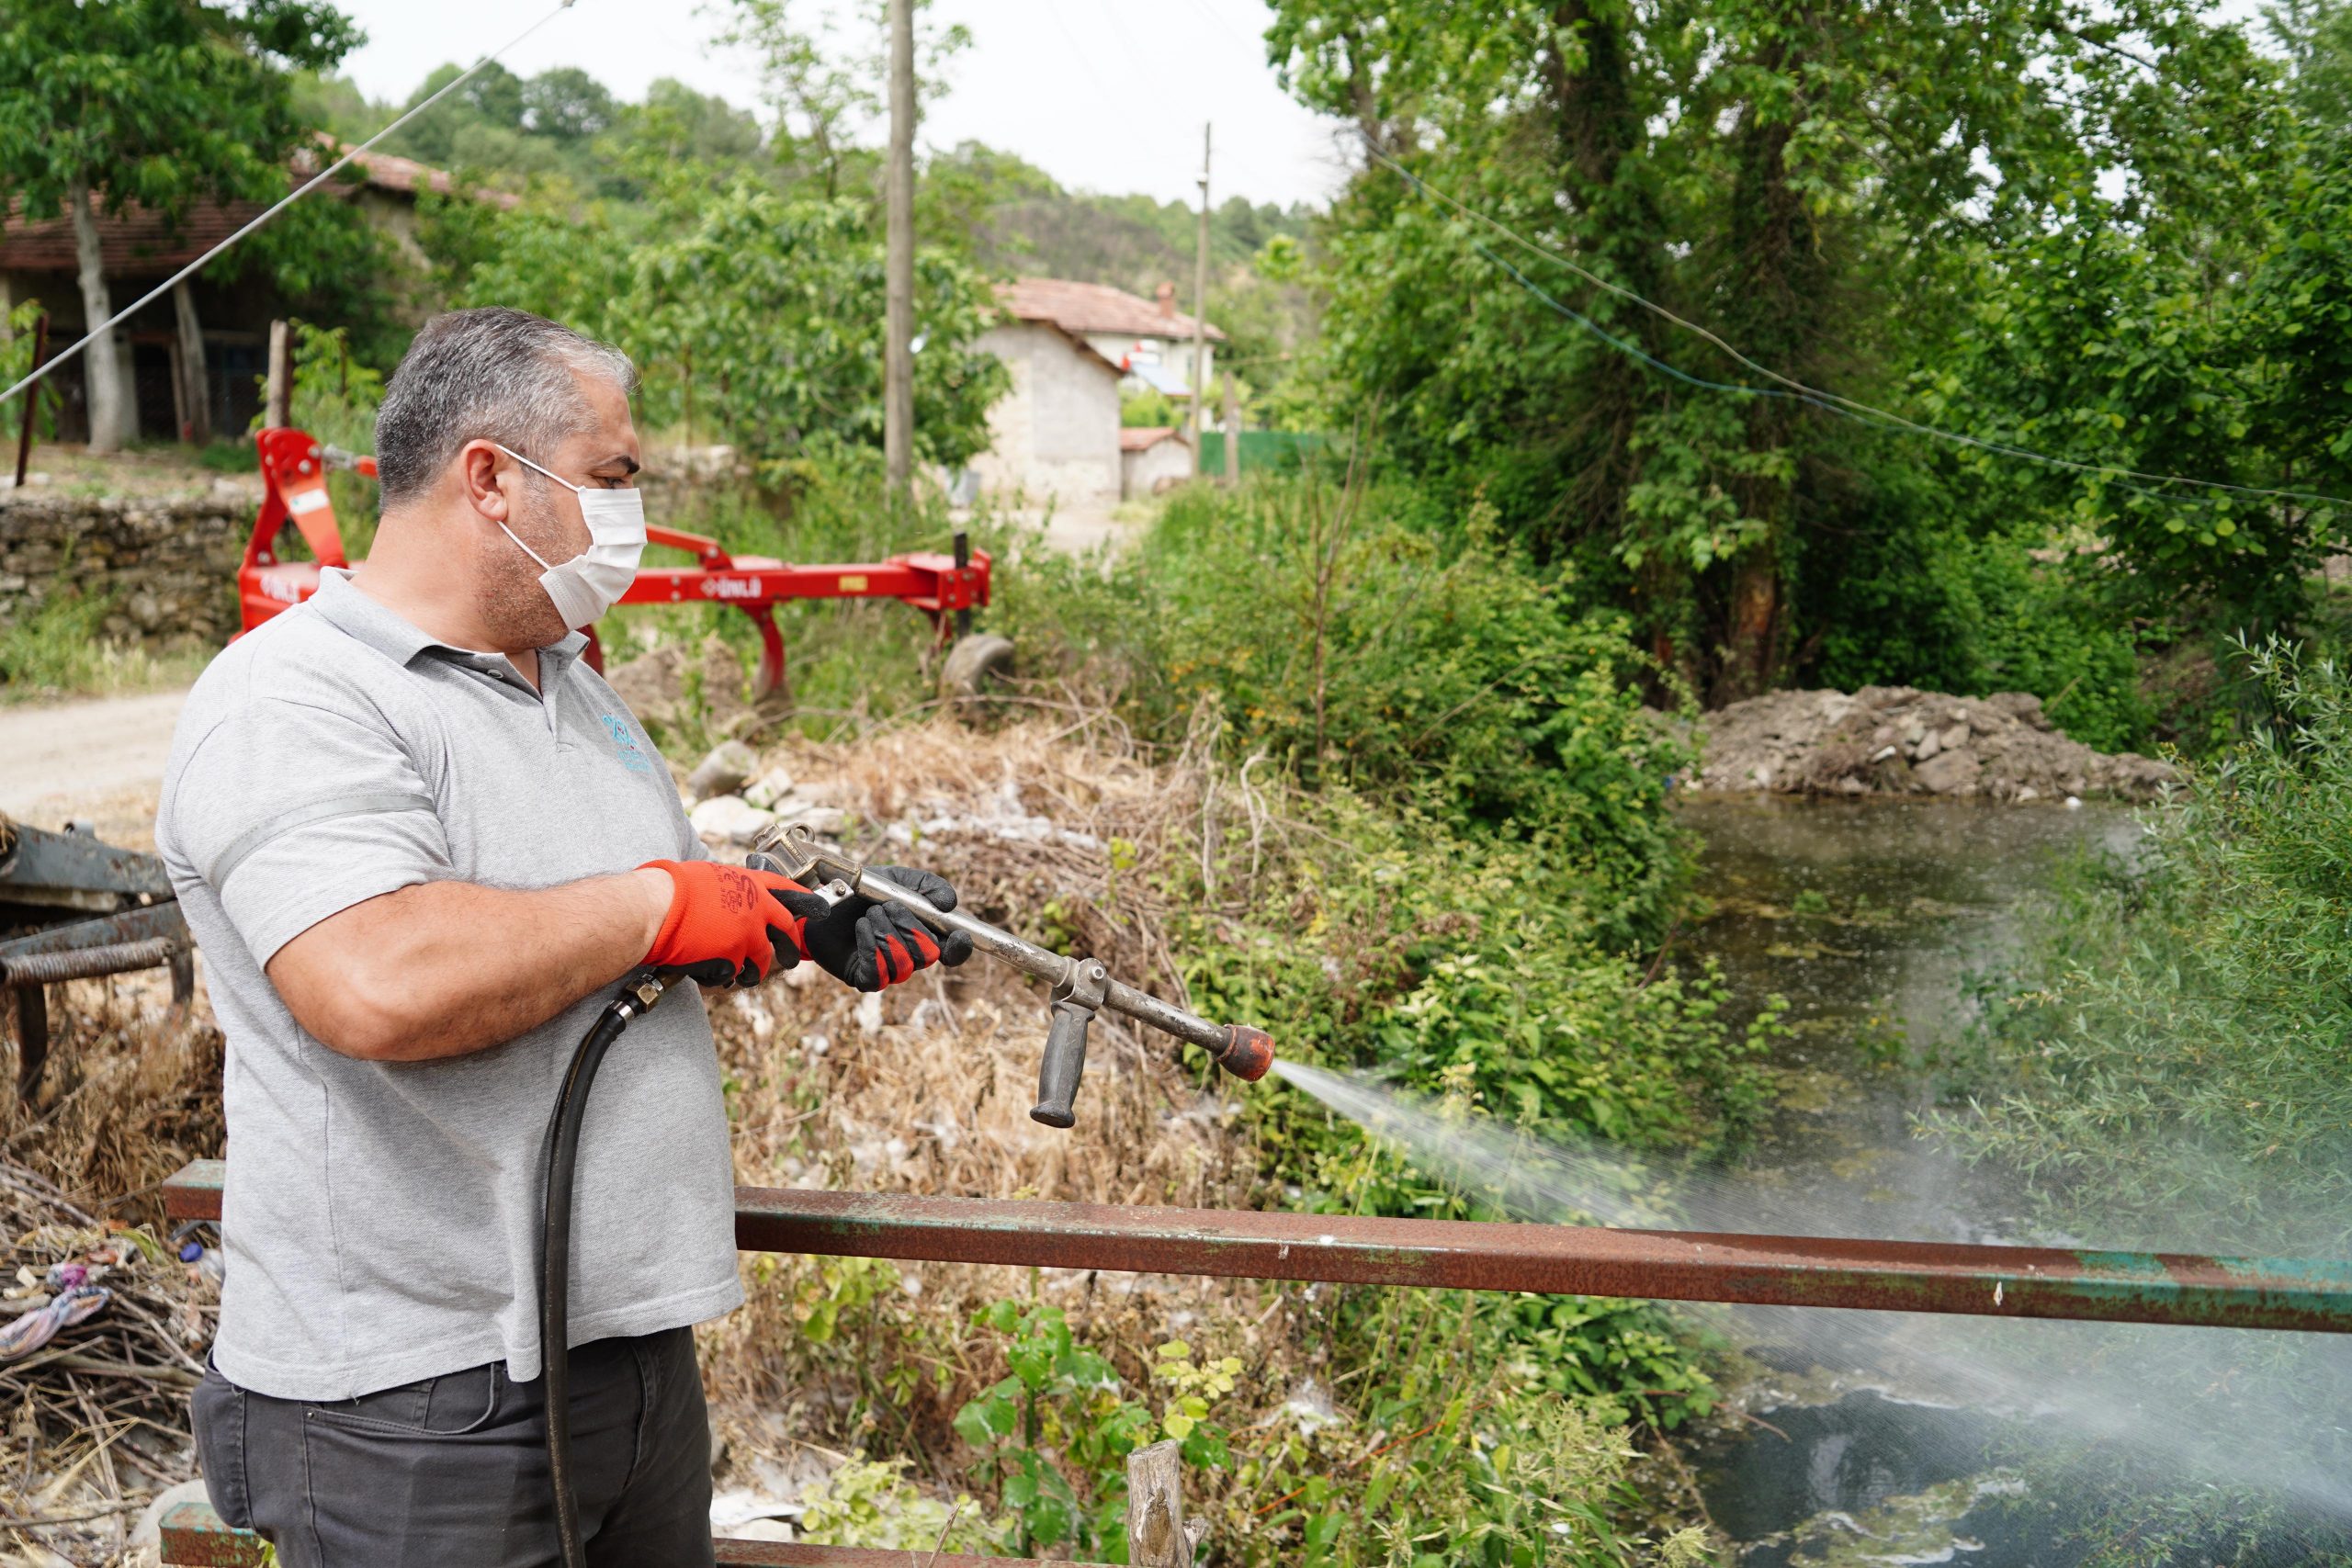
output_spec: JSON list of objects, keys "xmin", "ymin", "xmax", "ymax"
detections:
[{"xmin": 155, "ymin": 310, "xmax": 971, "ymax": 1568}]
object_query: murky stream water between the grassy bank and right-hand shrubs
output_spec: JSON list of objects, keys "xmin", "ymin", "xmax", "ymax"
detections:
[{"xmin": 1681, "ymin": 799, "xmax": 2343, "ymax": 1568}]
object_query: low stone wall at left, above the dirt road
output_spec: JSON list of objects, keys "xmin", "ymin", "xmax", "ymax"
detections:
[{"xmin": 0, "ymin": 482, "xmax": 256, "ymax": 651}]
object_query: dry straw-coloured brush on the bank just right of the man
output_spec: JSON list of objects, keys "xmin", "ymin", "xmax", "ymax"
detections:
[{"xmin": 703, "ymin": 715, "xmax": 1317, "ymax": 1523}]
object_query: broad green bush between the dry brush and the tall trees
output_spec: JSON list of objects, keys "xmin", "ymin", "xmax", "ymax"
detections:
[{"xmin": 1000, "ymin": 478, "xmax": 1689, "ymax": 945}]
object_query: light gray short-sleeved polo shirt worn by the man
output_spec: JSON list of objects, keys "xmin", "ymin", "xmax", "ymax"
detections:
[{"xmin": 155, "ymin": 571, "xmax": 743, "ymax": 1399}]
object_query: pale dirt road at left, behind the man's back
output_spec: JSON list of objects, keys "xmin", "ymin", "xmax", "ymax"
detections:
[{"xmin": 0, "ymin": 691, "xmax": 186, "ymax": 849}]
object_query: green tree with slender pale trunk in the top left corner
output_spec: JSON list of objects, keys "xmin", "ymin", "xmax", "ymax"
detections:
[{"xmin": 0, "ymin": 0, "xmax": 362, "ymax": 451}]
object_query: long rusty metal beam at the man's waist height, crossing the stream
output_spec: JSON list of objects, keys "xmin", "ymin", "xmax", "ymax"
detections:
[{"xmin": 164, "ymin": 1161, "xmax": 2352, "ymax": 1333}]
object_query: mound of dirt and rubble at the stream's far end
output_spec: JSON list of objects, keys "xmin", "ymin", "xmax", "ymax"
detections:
[{"xmin": 1698, "ymin": 686, "xmax": 2178, "ymax": 802}]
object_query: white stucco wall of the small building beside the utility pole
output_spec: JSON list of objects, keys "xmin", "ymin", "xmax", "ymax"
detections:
[{"xmin": 971, "ymin": 322, "xmax": 1120, "ymax": 501}]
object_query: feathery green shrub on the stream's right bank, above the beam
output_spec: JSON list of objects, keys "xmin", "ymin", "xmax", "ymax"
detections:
[{"xmin": 1943, "ymin": 644, "xmax": 2352, "ymax": 1256}]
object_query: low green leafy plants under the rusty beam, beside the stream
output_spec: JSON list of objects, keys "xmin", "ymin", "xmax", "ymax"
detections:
[{"xmin": 945, "ymin": 1291, "xmax": 1705, "ymax": 1568}]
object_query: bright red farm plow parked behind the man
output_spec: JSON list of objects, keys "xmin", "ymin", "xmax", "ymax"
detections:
[{"xmin": 238, "ymin": 430, "xmax": 1012, "ymax": 698}]
